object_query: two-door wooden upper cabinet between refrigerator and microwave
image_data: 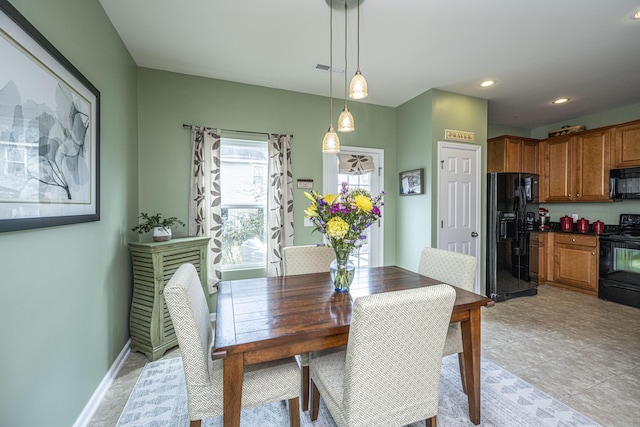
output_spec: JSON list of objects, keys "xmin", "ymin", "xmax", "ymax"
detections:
[{"xmin": 540, "ymin": 128, "xmax": 611, "ymax": 202}]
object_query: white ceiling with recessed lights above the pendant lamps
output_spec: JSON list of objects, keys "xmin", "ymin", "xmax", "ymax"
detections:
[{"xmin": 100, "ymin": 0, "xmax": 640, "ymax": 129}]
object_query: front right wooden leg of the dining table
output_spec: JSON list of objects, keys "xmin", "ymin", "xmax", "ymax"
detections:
[{"xmin": 460, "ymin": 308, "xmax": 480, "ymax": 425}]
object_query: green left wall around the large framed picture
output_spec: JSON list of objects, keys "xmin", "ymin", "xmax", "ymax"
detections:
[{"xmin": 0, "ymin": 0, "xmax": 138, "ymax": 426}]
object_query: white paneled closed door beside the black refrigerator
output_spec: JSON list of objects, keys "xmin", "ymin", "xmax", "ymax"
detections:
[{"xmin": 438, "ymin": 141, "xmax": 482, "ymax": 292}]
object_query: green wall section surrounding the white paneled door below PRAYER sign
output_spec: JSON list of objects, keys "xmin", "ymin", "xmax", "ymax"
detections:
[{"xmin": 396, "ymin": 89, "xmax": 487, "ymax": 280}]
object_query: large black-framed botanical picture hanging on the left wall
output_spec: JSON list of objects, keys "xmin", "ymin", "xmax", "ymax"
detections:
[{"xmin": 0, "ymin": 0, "xmax": 100, "ymax": 232}]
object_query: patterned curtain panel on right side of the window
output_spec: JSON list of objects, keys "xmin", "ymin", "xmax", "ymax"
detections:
[{"xmin": 267, "ymin": 134, "xmax": 293, "ymax": 276}]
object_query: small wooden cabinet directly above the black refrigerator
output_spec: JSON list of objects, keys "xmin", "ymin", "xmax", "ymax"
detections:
[{"xmin": 487, "ymin": 135, "xmax": 538, "ymax": 173}]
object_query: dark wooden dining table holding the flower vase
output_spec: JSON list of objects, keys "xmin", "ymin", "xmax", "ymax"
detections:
[{"xmin": 211, "ymin": 266, "xmax": 493, "ymax": 427}]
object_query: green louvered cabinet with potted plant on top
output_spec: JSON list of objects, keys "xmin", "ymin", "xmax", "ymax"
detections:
[{"xmin": 129, "ymin": 237, "xmax": 210, "ymax": 361}]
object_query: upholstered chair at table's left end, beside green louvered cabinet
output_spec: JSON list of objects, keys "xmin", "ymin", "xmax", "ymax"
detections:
[{"xmin": 164, "ymin": 264, "xmax": 300, "ymax": 427}]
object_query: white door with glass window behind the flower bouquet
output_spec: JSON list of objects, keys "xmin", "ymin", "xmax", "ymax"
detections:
[{"xmin": 322, "ymin": 145, "xmax": 384, "ymax": 268}]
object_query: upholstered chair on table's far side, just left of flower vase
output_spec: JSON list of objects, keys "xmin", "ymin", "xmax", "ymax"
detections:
[{"xmin": 282, "ymin": 245, "xmax": 336, "ymax": 411}]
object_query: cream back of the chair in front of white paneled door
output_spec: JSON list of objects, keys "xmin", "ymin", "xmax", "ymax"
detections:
[{"xmin": 418, "ymin": 248, "xmax": 478, "ymax": 292}]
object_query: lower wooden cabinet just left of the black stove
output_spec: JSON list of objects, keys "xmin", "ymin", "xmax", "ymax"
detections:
[{"xmin": 552, "ymin": 233, "xmax": 599, "ymax": 296}]
